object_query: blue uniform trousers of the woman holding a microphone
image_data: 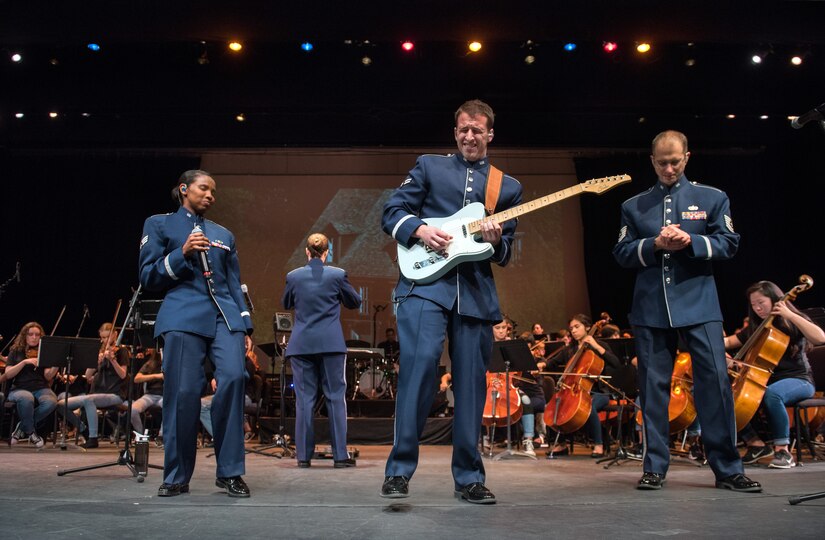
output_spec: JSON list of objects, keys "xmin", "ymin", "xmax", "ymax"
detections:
[{"xmin": 163, "ymin": 319, "xmax": 247, "ymax": 484}]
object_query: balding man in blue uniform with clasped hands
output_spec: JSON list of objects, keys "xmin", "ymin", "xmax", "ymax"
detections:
[{"xmin": 613, "ymin": 131, "xmax": 762, "ymax": 492}]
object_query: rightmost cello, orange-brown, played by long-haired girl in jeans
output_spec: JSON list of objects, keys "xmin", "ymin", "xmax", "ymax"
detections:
[{"xmin": 731, "ymin": 274, "xmax": 814, "ymax": 431}]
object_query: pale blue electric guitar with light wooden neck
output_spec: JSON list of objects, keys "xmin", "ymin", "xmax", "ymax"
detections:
[{"xmin": 398, "ymin": 174, "xmax": 630, "ymax": 285}]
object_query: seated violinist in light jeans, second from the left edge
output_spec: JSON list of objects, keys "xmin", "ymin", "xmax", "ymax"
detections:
[{"xmin": 58, "ymin": 322, "xmax": 129, "ymax": 448}]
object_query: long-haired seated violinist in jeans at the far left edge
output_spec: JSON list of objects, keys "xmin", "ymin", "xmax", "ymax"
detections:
[{"xmin": 3, "ymin": 322, "xmax": 58, "ymax": 448}]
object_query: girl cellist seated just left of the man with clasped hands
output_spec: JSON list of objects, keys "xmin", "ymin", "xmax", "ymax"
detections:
[{"xmin": 548, "ymin": 313, "xmax": 621, "ymax": 458}]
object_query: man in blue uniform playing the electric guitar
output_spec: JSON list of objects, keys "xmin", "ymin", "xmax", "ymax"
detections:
[{"xmin": 381, "ymin": 100, "xmax": 521, "ymax": 504}]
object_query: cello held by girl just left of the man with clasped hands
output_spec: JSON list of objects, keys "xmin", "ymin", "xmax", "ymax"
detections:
[{"xmin": 544, "ymin": 313, "xmax": 610, "ymax": 433}]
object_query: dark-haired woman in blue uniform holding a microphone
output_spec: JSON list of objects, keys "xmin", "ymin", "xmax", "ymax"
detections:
[{"xmin": 140, "ymin": 170, "xmax": 252, "ymax": 497}]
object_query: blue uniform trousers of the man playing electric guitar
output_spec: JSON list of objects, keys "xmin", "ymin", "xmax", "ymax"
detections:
[{"xmin": 385, "ymin": 296, "xmax": 493, "ymax": 489}]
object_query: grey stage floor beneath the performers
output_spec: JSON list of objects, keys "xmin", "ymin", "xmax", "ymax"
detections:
[{"xmin": 0, "ymin": 441, "xmax": 825, "ymax": 540}]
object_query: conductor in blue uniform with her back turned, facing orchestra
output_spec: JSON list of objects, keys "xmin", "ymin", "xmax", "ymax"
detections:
[{"xmin": 282, "ymin": 233, "xmax": 361, "ymax": 469}]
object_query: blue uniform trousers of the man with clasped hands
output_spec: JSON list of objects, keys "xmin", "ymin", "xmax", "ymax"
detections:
[{"xmin": 633, "ymin": 322, "xmax": 744, "ymax": 479}]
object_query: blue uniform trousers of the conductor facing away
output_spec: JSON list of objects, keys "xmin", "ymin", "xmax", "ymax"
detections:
[{"xmin": 289, "ymin": 353, "xmax": 348, "ymax": 461}]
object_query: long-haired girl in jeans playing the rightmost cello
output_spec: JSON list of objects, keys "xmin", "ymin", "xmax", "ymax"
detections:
[{"xmin": 725, "ymin": 281, "xmax": 825, "ymax": 469}]
